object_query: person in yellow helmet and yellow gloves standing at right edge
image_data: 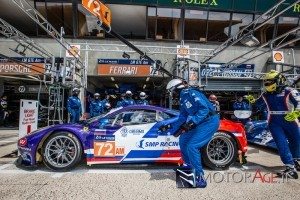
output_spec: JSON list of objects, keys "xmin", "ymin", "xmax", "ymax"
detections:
[{"xmin": 247, "ymin": 70, "xmax": 300, "ymax": 179}]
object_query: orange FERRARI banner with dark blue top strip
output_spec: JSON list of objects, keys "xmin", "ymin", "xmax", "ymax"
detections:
[{"xmin": 98, "ymin": 59, "xmax": 159, "ymax": 77}]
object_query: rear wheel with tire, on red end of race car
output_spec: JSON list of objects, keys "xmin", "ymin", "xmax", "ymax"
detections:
[{"xmin": 201, "ymin": 132, "xmax": 238, "ymax": 170}]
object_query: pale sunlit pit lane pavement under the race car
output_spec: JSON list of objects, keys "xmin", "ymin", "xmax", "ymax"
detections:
[{"xmin": 0, "ymin": 130, "xmax": 300, "ymax": 200}]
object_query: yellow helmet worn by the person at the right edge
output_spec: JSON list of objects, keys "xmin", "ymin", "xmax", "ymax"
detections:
[{"xmin": 264, "ymin": 70, "xmax": 286, "ymax": 92}]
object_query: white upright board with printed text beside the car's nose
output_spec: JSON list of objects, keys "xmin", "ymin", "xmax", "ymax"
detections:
[{"xmin": 19, "ymin": 99, "xmax": 38, "ymax": 138}]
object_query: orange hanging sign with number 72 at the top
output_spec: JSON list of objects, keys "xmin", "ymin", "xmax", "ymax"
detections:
[{"xmin": 82, "ymin": 0, "xmax": 111, "ymax": 27}]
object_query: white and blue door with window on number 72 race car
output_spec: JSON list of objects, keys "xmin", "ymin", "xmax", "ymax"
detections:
[{"xmin": 115, "ymin": 109, "xmax": 159, "ymax": 163}]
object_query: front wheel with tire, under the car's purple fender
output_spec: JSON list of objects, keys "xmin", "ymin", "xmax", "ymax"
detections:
[{"xmin": 42, "ymin": 132, "xmax": 82, "ymax": 171}]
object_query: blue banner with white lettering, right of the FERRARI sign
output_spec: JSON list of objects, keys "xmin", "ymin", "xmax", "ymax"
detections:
[{"xmin": 201, "ymin": 63, "xmax": 255, "ymax": 78}]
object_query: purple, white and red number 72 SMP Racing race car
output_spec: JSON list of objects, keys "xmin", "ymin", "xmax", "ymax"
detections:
[{"xmin": 17, "ymin": 105, "xmax": 247, "ymax": 171}]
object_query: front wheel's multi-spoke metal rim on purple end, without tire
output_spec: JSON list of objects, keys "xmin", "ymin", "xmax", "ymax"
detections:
[{"xmin": 45, "ymin": 136, "xmax": 77, "ymax": 168}]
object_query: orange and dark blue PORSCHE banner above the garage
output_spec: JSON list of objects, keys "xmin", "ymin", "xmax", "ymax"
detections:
[{"xmin": 0, "ymin": 57, "xmax": 45, "ymax": 75}]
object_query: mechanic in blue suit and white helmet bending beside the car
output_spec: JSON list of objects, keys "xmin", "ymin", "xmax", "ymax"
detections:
[{"xmin": 167, "ymin": 79, "xmax": 220, "ymax": 188}]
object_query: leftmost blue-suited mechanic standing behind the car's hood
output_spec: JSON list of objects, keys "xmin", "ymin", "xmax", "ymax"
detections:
[{"xmin": 67, "ymin": 88, "xmax": 82, "ymax": 123}]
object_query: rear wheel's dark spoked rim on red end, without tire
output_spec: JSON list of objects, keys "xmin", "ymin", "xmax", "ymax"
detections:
[{"xmin": 206, "ymin": 136, "xmax": 234, "ymax": 165}]
